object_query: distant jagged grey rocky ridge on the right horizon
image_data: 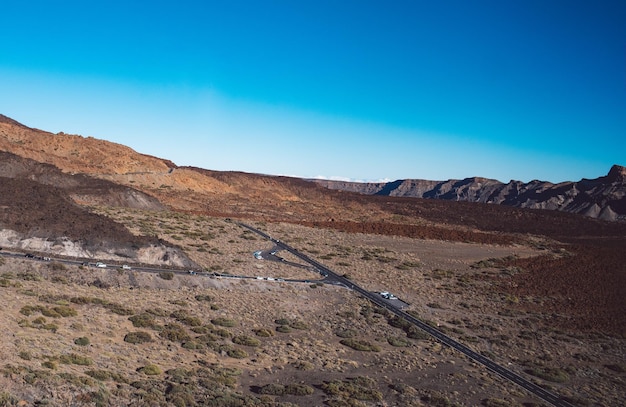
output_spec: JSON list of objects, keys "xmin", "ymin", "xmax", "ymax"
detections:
[{"xmin": 311, "ymin": 165, "xmax": 626, "ymax": 221}]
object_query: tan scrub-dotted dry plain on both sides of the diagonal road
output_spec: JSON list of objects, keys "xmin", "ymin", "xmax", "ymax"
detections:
[{"xmin": 0, "ymin": 208, "xmax": 625, "ymax": 406}]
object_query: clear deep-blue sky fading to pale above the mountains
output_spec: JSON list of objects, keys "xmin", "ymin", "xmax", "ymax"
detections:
[{"xmin": 0, "ymin": 0, "xmax": 626, "ymax": 182}]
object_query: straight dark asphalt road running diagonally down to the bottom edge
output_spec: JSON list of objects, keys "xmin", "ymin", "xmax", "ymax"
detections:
[{"xmin": 238, "ymin": 223, "xmax": 573, "ymax": 407}]
